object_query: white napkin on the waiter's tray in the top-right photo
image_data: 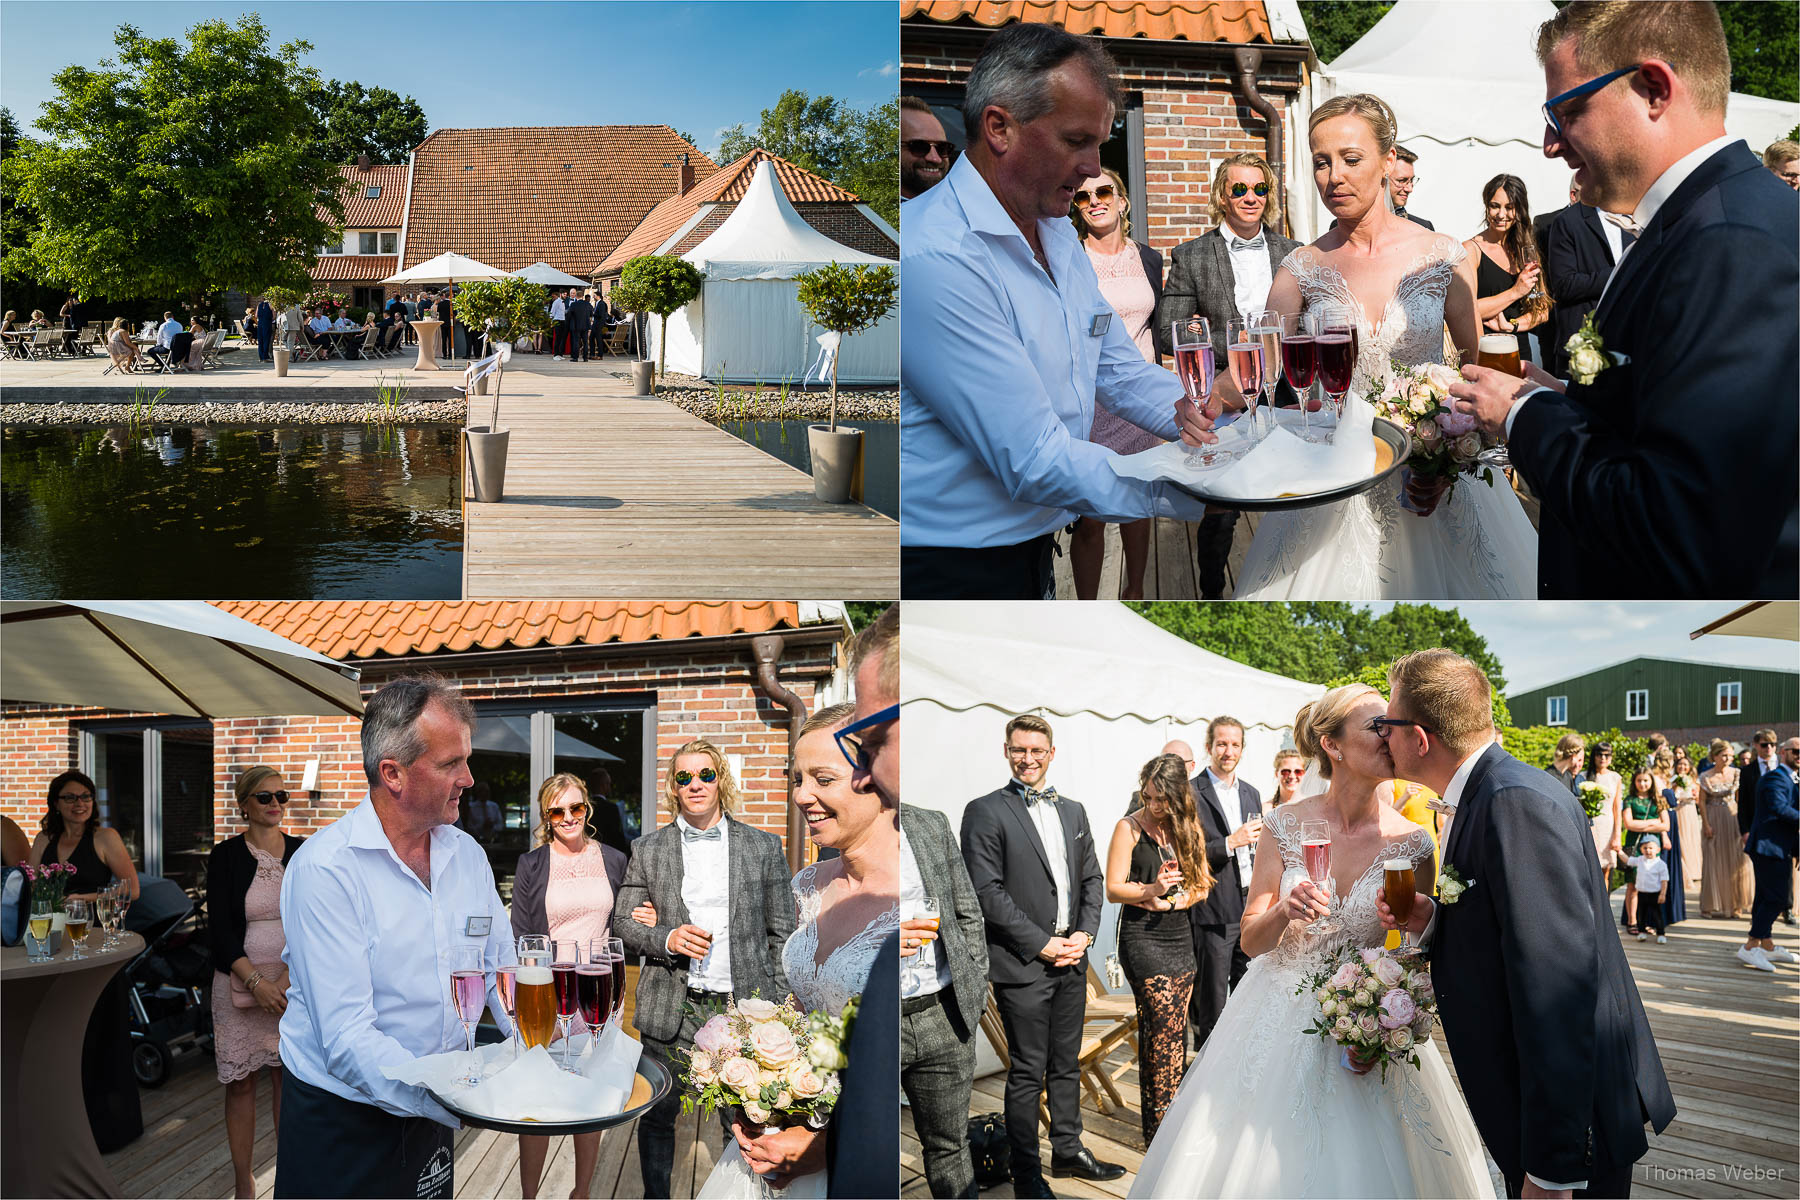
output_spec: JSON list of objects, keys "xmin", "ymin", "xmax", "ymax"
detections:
[{"xmin": 1112, "ymin": 394, "xmax": 1375, "ymax": 500}]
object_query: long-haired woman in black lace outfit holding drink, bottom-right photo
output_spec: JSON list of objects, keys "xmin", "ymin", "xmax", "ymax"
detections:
[{"xmin": 1107, "ymin": 754, "xmax": 1213, "ymax": 1146}]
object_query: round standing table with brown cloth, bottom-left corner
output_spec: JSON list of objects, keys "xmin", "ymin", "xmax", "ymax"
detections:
[{"xmin": 0, "ymin": 934, "xmax": 144, "ymax": 1196}]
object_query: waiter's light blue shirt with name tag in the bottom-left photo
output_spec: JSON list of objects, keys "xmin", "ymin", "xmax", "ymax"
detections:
[{"xmin": 281, "ymin": 801, "xmax": 513, "ymax": 1129}]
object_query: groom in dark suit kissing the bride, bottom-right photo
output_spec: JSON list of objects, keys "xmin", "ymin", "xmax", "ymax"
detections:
[{"xmin": 1375, "ymin": 649, "xmax": 1676, "ymax": 1196}]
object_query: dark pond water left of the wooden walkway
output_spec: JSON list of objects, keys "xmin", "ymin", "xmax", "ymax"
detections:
[{"xmin": 0, "ymin": 425, "xmax": 463, "ymax": 599}]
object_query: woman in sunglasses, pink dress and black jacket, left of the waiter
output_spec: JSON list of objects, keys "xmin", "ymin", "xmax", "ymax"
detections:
[{"xmin": 207, "ymin": 766, "xmax": 301, "ymax": 1196}]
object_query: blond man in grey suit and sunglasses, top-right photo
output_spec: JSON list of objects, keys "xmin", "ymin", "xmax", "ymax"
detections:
[{"xmin": 1157, "ymin": 153, "xmax": 1300, "ymax": 599}]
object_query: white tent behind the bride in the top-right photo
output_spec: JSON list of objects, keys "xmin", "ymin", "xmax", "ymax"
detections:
[{"xmin": 1289, "ymin": 0, "xmax": 1800, "ymax": 241}]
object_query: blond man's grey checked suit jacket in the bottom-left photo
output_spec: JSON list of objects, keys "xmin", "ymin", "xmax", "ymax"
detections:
[{"xmin": 612, "ymin": 817, "xmax": 796, "ymax": 1042}]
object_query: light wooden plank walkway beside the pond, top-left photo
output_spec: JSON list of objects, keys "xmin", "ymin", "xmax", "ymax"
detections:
[{"xmin": 463, "ymin": 368, "xmax": 900, "ymax": 599}]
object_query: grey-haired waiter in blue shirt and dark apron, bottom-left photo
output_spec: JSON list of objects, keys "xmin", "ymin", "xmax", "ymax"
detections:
[{"xmin": 275, "ymin": 676, "xmax": 513, "ymax": 1196}]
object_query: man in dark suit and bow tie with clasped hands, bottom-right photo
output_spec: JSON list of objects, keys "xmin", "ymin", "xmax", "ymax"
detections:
[{"xmin": 963, "ymin": 716, "xmax": 1125, "ymax": 1196}]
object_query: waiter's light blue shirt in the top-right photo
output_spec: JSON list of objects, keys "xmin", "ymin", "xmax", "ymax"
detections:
[{"xmin": 900, "ymin": 157, "xmax": 1201, "ymax": 547}]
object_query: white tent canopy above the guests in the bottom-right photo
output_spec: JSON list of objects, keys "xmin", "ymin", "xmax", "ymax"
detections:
[{"xmin": 900, "ymin": 601, "xmax": 1325, "ymax": 1021}]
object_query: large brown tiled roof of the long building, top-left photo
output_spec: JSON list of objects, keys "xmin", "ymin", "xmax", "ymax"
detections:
[{"xmin": 405, "ymin": 124, "xmax": 718, "ymax": 277}]
